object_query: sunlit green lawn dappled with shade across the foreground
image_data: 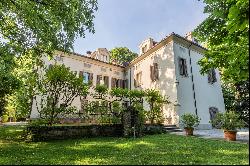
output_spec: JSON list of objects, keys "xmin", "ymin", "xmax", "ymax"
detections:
[{"xmin": 0, "ymin": 126, "xmax": 249, "ymax": 165}]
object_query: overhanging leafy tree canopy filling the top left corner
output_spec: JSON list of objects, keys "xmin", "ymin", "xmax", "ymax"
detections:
[{"xmin": 0, "ymin": 0, "xmax": 97, "ymax": 55}]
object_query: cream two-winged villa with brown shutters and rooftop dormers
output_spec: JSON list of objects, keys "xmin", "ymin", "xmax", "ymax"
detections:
[{"xmin": 31, "ymin": 33, "xmax": 225, "ymax": 129}]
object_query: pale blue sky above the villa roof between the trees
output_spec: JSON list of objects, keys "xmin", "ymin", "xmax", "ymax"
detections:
[{"xmin": 74, "ymin": 0, "xmax": 207, "ymax": 54}]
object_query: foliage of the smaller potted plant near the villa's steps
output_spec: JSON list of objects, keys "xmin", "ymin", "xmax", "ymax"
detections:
[{"xmin": 181, "ymin": 113, "xmax": 200, "ymax": 128}]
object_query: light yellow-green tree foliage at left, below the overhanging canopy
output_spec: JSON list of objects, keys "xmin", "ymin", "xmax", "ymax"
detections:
[{"xmin": 8, "ymin": 50, "xmax": 43, "ymax": 118}]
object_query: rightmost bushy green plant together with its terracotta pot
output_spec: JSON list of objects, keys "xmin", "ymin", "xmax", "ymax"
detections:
[{"xmin": 211, "ymin": 111, "xmax": 244, "ymax": 141}]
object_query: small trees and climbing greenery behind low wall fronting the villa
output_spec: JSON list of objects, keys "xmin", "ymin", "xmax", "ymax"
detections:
[{"xmin": 2, "ymin": 64, "xmax": 170, "ymax": 141}]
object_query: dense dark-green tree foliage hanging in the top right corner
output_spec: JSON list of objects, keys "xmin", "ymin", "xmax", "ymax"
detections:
[{"xmin": 194, "ymin": 0, "xmax": 249, "ymax": 83}]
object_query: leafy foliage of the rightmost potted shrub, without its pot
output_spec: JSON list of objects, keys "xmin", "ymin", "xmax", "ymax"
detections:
[{"xmin": 210, "ymin": 111, "xmax": 244, "ymax": 131}]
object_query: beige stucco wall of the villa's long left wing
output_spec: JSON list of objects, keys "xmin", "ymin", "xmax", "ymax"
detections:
[{"xmin": 31, "ymin": 51, "xmax": 124, "ymax": 118}]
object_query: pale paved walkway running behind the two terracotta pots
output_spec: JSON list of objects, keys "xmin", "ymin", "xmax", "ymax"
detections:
[{"xmin": 171, "ymin": 129, "xmax": 249, "ymax": 143}]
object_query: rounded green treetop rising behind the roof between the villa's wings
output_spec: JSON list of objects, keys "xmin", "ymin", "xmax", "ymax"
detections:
[{"xmin": 110, "ymin": 47, "xmax": 138, "ymax": 64}]
